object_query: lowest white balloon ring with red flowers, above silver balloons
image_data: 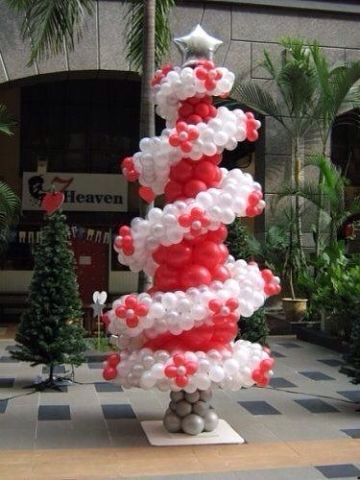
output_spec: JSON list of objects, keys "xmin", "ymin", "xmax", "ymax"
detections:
[{"xmin": 105, "ymin": 340, "xmax": 273, "ymax": 393}]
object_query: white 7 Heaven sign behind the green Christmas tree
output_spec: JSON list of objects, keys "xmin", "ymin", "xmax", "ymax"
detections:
[{"xmin": 22, "ymin": 172, "xmax": 127, "ymax": 212}]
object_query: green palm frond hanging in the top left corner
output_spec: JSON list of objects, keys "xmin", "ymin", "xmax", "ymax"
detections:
[{"xmin": 5, "ymin": 0, "xmax": 94, "ymax": 65}]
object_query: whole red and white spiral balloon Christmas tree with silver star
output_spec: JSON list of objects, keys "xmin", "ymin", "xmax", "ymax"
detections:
[{"xmin": 103, "ymin": 26, "xmax": 280, "ymax": 435}]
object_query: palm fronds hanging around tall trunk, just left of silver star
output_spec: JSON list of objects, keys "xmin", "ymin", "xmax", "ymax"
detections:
[{"xmin": 126, "ymin": 0, "xmax": 175, "ymax": 71}]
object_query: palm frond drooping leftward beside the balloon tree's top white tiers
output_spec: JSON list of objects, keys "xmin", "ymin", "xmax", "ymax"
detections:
[{"xmin": 231, "ymin": 82, "xmax": 285, "ymax": 126}]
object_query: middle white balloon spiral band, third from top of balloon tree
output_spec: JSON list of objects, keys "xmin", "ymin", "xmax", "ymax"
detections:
[{"xmin": 114, "ymin": 168, "xmax": 265, "ymax": 275}]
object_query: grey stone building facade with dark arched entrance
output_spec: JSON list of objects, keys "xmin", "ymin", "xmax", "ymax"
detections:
[{"xmin": 0, "ymin": 0, "xmax": 360, "ymax": 302}]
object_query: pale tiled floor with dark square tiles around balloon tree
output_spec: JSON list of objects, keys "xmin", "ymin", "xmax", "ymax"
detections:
[{"xmin": 0, "ymin": 337, "xmax": 360, "ymax": 480}]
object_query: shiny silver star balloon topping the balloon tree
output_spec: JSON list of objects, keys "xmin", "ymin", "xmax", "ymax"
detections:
[{"xmin": 174, "ymin": 25, "xmax": 223, "ymax": 65}]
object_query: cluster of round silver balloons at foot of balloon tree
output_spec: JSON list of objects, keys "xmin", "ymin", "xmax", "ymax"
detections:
[{"xmin": 163, "ymin": 389, "xmax": 219, "ymax": 435}]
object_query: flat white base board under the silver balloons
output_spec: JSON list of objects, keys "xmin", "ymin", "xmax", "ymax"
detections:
[{"xmin": 141, "ymin": 420, "xmax": 245, "ymax": 447}]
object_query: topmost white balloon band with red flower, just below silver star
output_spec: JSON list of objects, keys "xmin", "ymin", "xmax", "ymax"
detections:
[{"xmin": 153, "ymin": 64, "xmax": 235, "ymax": 127}]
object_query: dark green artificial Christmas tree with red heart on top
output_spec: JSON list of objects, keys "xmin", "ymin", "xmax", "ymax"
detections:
[{"xmin": 11, "ymin": 200, "xmax": 86, "ymax": 389}]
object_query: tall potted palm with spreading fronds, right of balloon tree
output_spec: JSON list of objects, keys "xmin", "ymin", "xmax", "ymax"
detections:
[{"xmin": 232, "ymin": 38, "xmax": 360, "ymax": 321}]
